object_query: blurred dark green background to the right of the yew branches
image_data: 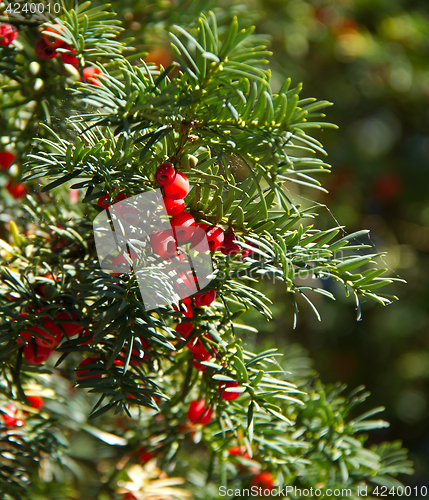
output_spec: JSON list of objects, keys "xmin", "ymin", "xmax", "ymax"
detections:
[{"xmin": 113, "ymin": 0, "xmax": 429, "ymax": 486}]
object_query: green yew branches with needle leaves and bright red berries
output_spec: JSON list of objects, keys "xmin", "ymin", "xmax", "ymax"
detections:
[{"xmin": 0, "ymin": 2, "xmax": 411, "ymax": 500}]
